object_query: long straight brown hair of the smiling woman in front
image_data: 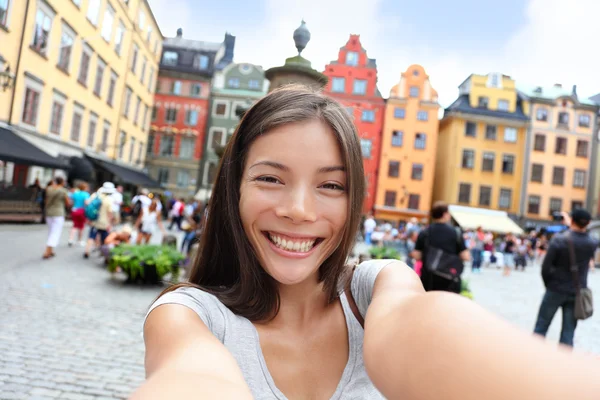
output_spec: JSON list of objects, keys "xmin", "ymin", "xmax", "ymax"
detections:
[{"xmin": 161, "ymin": 85, "xmax": 366, "ymax": 321}]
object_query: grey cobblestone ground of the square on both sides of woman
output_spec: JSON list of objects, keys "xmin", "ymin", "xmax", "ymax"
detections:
[{"xmin": 0, "ymin": 225, "xmax": 600, "ymax": 400}]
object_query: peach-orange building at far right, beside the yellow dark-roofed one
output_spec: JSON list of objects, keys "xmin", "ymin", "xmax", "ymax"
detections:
[{"xmin": 519, "ymin": 84, "xmax": 598, "ymax": 225}]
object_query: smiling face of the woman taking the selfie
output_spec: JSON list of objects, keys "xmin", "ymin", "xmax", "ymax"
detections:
[{"xmin": 240, "ymin": 120, "xmax": 348, "ymax": 285}]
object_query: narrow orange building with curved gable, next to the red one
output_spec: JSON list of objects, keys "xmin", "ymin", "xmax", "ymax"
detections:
[{"xmin": 375, "ymin": 65, "xmax": 439, "ymax": 221}]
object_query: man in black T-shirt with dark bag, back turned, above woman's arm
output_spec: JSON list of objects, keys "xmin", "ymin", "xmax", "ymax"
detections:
[{"xmin": 412, "ymin": 202, "xmax": 470, "ymax": 293}]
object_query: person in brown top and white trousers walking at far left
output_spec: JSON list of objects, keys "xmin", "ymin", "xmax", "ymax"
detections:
[{"xmin": 42, "ymin": 176, "xmax": 71, "ymax": 259}]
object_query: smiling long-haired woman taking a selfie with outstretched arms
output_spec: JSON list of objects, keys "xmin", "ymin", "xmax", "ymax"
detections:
[{"xmin": 133, "ymin": 87, "xmax": 600, "ymax": 400}]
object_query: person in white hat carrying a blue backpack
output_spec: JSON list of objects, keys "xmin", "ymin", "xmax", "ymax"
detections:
[{"xmin": 83, "ymin": 182, "xmax": 116, "ymax": 258}]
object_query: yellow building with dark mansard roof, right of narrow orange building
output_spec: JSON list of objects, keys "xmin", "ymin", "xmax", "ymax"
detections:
[{"xmin": 433, "ymin": 73, "xmax": 528, "ymax": 219}]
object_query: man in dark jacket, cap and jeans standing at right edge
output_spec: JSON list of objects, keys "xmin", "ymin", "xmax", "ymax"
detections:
[{"xmin": 534, "ymin": 209, "xmax": 598, "ymax": 346}]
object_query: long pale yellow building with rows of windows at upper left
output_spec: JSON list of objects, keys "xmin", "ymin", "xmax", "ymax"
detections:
[{"xmin": 0, "ymin": 0, "xmax": 163, "ymax": 185}]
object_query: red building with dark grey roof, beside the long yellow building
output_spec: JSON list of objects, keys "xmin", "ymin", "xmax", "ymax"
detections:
[{"xmin": 147, "ymin": 29, "xmax": 235, "ymax": 198}]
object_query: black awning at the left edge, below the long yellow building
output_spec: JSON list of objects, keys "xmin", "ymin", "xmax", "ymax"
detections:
[{"xmin": 0, "ymin": 128, "xmax": 70, "ymax": 170}]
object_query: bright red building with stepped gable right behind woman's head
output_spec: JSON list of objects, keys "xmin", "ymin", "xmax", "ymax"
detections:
[{"xmin": 323, "ymin": 35, "xmax": 385, "ymax": 212}]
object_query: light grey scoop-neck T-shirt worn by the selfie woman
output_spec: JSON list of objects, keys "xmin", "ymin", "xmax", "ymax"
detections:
[{"xmin": 144, "ymin": 260, "xmax": 394, "ymax": 400}]
